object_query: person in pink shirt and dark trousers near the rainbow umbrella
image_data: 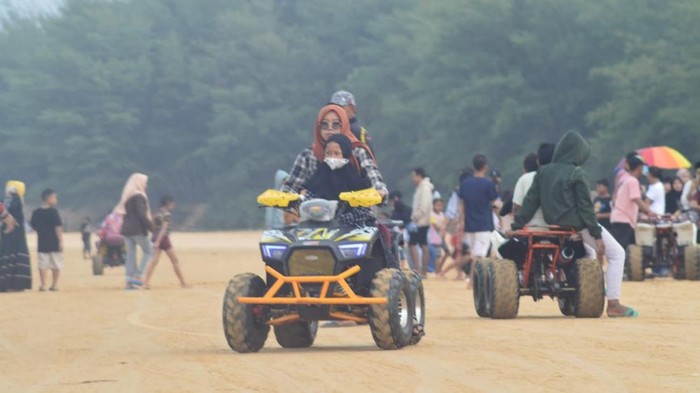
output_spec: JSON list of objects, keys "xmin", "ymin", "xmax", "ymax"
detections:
[{"xmin": 610, "ymin": 152, "xmax": 656, "ymax": 251}]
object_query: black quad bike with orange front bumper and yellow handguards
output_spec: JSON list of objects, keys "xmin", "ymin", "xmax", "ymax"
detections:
[{"xmin": 223, "ymin": 189, "xmax": 425, "ymax": 353}]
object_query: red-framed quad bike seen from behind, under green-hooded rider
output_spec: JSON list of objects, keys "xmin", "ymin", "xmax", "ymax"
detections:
[{"xmin": 473, "ymin": 227, "xmax": 605, "ymax": 319}]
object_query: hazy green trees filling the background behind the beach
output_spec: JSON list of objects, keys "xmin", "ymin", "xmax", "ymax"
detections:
[{"xmin": 0, "ymin": 0, "xmax": 700, "ymax": 228}]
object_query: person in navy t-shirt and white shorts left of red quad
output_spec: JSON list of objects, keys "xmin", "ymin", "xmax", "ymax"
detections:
[{"xmin": 458, "ymin": 154, "xmax": 502, "ymax": 288}]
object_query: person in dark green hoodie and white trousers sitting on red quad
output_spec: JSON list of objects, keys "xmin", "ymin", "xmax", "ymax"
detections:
[{"xmin": 512, "ymin": 131, "xmax": 637, "ymax": 317}]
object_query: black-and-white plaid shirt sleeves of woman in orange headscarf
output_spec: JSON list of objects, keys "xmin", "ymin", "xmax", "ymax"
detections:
[{"xmin": 281, "ymin": 147, "xmax": 388, "ymax": 195}]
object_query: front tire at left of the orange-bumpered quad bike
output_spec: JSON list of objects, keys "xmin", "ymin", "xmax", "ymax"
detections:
[{"xmin": 222, "ymin": 273, "xmax": 270, "ymax": 353}]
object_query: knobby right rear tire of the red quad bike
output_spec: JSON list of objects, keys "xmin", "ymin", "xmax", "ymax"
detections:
[{"xmin": 573, "ymin": 259, "xmax": 605, "ymax": 318}]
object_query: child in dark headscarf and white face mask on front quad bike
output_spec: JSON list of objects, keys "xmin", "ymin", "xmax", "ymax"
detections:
[{"xmin": 303, "ymin": 134, "xmax": 374, "ymax": 225}]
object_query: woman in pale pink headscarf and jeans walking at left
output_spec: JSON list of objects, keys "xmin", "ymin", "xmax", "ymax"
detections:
[{"xmin": 114, "ymin": 173, "xmax": 153, "ymax": 290}]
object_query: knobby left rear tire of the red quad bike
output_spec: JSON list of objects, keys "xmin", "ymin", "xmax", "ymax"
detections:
[{"xmin": 486, "ymin": 259, "xmax": 520, "ymax": 319}]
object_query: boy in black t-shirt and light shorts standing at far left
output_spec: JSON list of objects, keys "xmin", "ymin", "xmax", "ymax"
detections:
[{"xmin": 31, "ymin": 188, "xmax": 63, "ymax": 292}]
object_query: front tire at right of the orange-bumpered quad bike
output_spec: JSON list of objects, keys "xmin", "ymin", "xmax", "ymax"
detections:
[{"xmin": 369, "ymin": 269, "xmax": 414, "ymax": 349}]
